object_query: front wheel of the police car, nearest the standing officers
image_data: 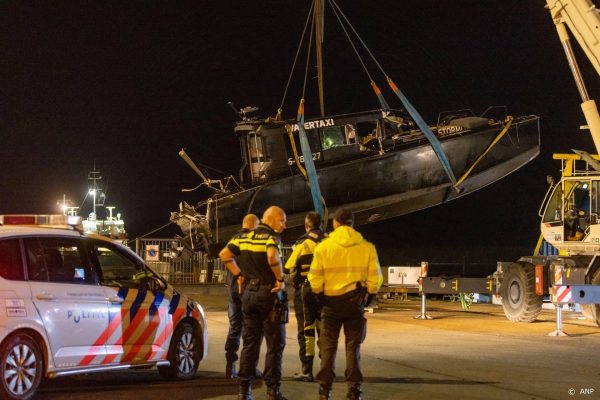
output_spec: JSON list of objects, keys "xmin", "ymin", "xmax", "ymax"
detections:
[{"xmin": 158, "ymin": 322, "xmax": 201, "ymax": 380}]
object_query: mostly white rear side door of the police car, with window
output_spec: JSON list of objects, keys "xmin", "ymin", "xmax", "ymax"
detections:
[{"xmin": 23, "ymin": 237, "xmax": 108, "ymax": 368}]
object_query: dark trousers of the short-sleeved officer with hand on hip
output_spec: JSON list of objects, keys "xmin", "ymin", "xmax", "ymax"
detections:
[{"xmin": 238, "ymin": 285, "xmax": 285, "ymax": 386}]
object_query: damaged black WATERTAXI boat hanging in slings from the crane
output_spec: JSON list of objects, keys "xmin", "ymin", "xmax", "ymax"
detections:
[{"xmin": 171, "ymin": 0, "xmax": 540, "ymax": 251}]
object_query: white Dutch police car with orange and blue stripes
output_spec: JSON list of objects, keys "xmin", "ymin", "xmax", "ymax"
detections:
[{"xmin": 0, "ymin": 215, "xmax": 208, "ymax": 400}]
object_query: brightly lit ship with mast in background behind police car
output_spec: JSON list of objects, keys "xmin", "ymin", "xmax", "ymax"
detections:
[{"xmin": 57, "ymin": 166, "xmax": 127, "ymax": 243}]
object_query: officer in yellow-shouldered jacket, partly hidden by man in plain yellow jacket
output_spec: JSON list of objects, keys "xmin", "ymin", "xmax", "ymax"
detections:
[{"xmin": 284, "ymin": 211, "xmax": 323, "ymax": 382}]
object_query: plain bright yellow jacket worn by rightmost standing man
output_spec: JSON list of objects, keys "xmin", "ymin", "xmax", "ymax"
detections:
[{"xmin": 308, "ymin": 225, "xmax": 383, "ymax": 296}]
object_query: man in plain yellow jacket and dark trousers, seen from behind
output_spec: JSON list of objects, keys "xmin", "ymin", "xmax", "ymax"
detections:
[{"xmin": 308, "ymin": 209, "xmax": 383, "ymax": 400}]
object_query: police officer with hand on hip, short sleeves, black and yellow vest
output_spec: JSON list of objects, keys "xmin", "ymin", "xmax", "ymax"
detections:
[{"xmin": 219, "ymin": 206, "xmax": 287, "ymax": 400}]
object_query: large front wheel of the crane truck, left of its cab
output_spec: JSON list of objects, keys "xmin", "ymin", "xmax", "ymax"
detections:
[{"xmin": 500, "ymin": 263, "xmax": 543, "ymax": 322}]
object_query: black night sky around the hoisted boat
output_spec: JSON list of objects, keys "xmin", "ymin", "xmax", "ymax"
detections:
[{"xmin": 0, "ymin": 0, "xmax": 600, "ymax": 264}]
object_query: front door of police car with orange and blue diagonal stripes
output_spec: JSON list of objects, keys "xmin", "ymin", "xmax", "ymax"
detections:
[{"xmin": 94, "ymin": 241, "xmax": 168, "ymax": 364}]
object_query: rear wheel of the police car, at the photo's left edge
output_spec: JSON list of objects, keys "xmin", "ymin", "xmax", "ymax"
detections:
[{"xmin": 0, "ymin": 333, "xmax": 44, "ymax": 400}]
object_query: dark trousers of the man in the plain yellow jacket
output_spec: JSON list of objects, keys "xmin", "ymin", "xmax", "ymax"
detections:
[{"xmin": 317, "ymin": 297, "xmax": 367, "ymax": 388}]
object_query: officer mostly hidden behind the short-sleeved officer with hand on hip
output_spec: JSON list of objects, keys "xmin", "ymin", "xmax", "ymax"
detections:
[{"xmin": 225, "ymin": 214, "xmax": 259, "ymax": 379}]
